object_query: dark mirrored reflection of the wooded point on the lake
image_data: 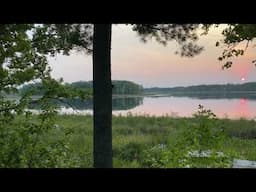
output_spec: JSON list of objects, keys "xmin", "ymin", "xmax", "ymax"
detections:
[{"xmin": 29, "ymin": 97, "xmax": 143, "ymax": 111}]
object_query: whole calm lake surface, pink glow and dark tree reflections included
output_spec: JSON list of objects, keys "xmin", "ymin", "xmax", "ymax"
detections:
[{"xmin": 35, "ymin": 96, "xmax": 256, "ymax": 119}]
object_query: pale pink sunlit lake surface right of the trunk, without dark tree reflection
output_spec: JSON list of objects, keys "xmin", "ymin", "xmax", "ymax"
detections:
[{"xmin": 113, "ymin": 97, "xmax": 256, "ymax": 119}]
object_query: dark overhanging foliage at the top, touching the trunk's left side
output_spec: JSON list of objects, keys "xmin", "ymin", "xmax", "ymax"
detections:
[{"xmin": 33, "ymin": 24, "xmax": 93, "ymax": 55}]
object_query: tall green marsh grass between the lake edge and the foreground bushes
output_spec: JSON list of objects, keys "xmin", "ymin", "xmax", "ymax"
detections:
[{"xmin": 6, "ymin": 114, "xmax": 256, "ymax": 168}]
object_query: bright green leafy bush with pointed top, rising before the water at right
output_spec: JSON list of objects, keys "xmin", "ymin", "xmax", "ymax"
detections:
[{"xmin": 142, "ymin": 105, "xmax": 233, "ymax": 168}]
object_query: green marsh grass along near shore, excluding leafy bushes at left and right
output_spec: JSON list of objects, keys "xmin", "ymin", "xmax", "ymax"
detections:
[{"xmin": 46, "ymin": 115, "xmax": 256, "ymax": 167}]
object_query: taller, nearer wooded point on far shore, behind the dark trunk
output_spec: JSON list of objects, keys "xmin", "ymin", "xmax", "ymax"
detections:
[{"xmin": 19, "ymin": 80, "xmax": 143, "ymax": 95}]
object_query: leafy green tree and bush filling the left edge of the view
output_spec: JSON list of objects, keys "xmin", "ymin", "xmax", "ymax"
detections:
[{"xmin": 0, "ymin": 24, "xmax": 91, "ymax": 167}]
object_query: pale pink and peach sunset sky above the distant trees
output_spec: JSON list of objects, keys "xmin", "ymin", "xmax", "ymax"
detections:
[{"xmin": 49, "ymin": 25, "xmax": 256, "ymax": 87}]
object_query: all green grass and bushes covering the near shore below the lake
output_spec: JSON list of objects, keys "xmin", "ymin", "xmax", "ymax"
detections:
[{"xmin": 1, "ymin": 106, "xmax": 256, "ymax": 168}]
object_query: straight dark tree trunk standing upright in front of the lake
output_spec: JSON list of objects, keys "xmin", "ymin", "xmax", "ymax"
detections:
[{"xmin": 93, "ymin": 24, "xmax": 113, "ymax": 168}]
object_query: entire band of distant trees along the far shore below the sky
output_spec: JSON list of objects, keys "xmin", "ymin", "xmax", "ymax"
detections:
[{"xmin": 22, "ymin": 80, "xmax": 256, "ymax": 98}]
